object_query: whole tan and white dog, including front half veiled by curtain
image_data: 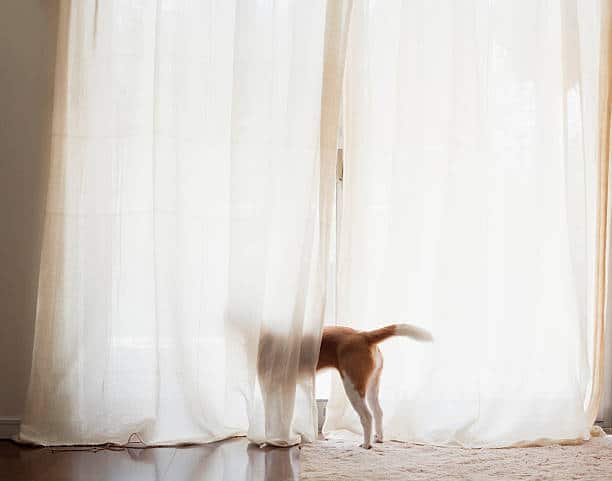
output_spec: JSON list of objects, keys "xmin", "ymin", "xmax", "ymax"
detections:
[{"xmin": 257, "ymin": 324, "xmax": 433, "ymax": 449}]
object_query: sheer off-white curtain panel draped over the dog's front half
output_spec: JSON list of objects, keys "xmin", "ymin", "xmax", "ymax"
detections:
[{"xmin": 20, "ymin": 0, "xmax": 346, "ymax": 444}]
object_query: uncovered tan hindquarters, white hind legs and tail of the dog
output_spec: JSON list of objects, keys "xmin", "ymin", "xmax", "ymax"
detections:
[{"xmin": 317, "ymin": 324, "xmax": 433, "ymax": 449}]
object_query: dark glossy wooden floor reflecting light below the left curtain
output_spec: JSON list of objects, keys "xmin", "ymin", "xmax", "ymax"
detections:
[{"xmin": 0, "ymin": 439, "xmax": 300, "ymax": 481}]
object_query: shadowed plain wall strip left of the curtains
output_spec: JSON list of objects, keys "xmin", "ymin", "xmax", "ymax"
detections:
[{"xmin": 0, "ymin": 0, "xmax": 59, "ymax": 435}]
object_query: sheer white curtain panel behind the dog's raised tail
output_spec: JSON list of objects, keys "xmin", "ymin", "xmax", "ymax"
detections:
[{"xmin": 325, "ymin": 0, "xmax": 609, "ymax": 446}]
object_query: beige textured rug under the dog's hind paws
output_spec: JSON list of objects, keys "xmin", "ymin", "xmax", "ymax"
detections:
[{"xmin": 300, "ymin": 436, "xmax": 612, "ymax": 481}]
